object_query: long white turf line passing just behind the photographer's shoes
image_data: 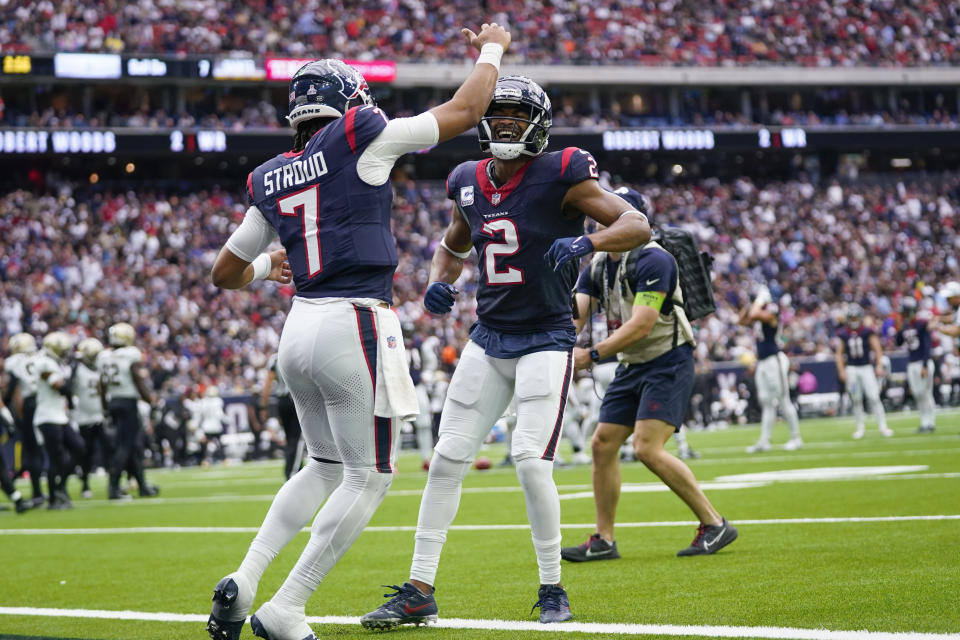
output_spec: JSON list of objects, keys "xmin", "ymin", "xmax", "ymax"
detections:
[{"xmin": 0, "ymin": 514, "xmax": 960, "ymax": 536}]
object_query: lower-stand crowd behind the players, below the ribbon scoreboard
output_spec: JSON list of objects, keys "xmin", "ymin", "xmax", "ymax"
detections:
[{"xmin": 0, "ymin": 172, "xmax": 960, "ymax": 394}]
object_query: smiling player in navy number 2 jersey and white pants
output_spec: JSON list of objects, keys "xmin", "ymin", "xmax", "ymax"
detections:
[{"xmin": 361, "ymin": 76, "xmax": 650, "ymax": 628}]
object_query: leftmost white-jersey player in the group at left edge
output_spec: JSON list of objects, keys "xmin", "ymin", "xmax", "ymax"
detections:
[{"xmin": 3, "ymin": 333, "xmax": 45, "ymax": 507}]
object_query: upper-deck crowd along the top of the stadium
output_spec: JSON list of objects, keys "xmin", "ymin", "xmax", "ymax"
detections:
[{"xmin": 0, "ymin": 0, "xmax": 960, "ymax": 67}]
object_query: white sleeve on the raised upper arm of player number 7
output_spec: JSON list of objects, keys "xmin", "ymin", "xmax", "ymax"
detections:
[{"xmin": 357, "ymin": 111, "xmax": 440, "ymax": 187}]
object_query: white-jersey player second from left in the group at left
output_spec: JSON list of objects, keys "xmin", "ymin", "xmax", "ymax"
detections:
[{"xmin": 33, "ymin": 331, "xmax": 83, "ymax": 509}]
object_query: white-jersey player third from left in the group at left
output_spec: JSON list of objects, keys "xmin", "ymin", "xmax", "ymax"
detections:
[{"xmin": 71, "ymin": 338, "xmax": 112, "ymax": 498}]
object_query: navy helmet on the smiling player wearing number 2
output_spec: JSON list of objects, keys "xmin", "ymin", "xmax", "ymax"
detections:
[{"xmin": 477, "ymin": 76, "xmax": 553, "ymax": 160}]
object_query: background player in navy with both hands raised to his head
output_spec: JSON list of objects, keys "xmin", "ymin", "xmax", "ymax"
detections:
[{"xmin": 739, "ymin": 287, "xmax": 803, "ymax": 453}]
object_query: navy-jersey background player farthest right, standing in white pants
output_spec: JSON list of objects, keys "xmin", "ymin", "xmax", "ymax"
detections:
[{"xmin": 896, "ymin": 297, "xmax": 939, "ymax": 433}]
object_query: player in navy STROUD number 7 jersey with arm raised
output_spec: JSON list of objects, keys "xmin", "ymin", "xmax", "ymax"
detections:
[{"xmin": 207, "ymin": 24, "xmax": 510, "ymax": 640}]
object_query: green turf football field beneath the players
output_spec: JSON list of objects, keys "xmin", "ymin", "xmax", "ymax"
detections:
[{"xmin": 0, "ymin": 414, "xmax": 960, "ymax": 640}]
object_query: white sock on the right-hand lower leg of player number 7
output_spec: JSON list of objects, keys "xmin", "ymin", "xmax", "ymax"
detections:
[{"xmin": 271, "ymin": 467, "xmax": 393, "ymax": 611}]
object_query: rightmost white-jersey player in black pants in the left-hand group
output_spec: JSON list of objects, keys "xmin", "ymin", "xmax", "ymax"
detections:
[{"xmin": 96, "ymin": 322, "xmax": 159, "ymax": 500}]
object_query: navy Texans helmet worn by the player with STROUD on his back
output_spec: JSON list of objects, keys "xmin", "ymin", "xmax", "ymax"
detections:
[{"xmin": 287, "ymin": 58, "xmax": 375, "ymax": 129}]
